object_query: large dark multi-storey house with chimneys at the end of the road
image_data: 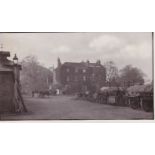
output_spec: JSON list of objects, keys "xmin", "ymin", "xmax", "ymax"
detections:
[{"xmin": 53, "ymin": 58, "xmax": 106, "ymax": 93}]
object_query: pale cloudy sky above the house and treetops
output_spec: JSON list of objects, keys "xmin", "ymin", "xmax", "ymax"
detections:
[{"xmin": 0, "ymin": 32, "xmax": 152, "ymax": 80}]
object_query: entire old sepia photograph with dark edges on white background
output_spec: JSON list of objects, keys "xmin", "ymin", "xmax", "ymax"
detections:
[{"xmin": 0, "ymin": 32, "xmax": 154, "ymax": 121}]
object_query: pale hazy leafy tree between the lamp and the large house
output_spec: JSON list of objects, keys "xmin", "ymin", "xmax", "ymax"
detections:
[{"xmin": 21, "ymin": 56, "xmax": 52, "ymax": 92}]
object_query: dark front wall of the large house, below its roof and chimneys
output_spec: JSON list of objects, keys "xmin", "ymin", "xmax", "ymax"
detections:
[{"xmin": 60, "ymin": 65, "xmax": 106, "ymax": 92}]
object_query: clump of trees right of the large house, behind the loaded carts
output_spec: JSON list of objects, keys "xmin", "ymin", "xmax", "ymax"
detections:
[{"xmin": 104, "ymin": 61, "xmax": 146, "ymax": 87}]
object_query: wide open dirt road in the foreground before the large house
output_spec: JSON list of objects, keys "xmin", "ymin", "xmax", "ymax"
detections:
[{"xmin": 1, "ymin": 96, "xmax": 153, "ymax": 120}]
